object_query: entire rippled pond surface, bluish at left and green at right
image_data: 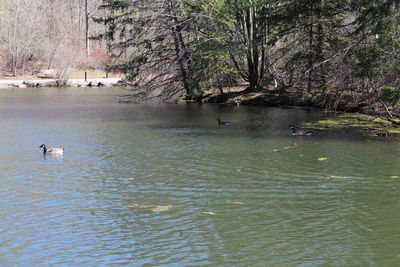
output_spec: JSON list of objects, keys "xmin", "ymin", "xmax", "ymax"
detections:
[{"xmin": 0, "ymin": 88, "xmax": 400, "ymax": 266}]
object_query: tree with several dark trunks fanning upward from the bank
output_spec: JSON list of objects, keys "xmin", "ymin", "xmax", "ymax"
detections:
[{"xmin": 200, "ymin": 0, "xmax": 279, "ymax": 91}]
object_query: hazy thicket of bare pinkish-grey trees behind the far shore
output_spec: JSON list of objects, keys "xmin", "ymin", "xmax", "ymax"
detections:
[{"xmin": 0, "ymin": 0, "xmax": 106, "ymax": 76}]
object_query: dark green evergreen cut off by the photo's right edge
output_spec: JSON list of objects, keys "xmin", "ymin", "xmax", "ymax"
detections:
[{"xmin": 354, "ymin": 0, "xmax": 400, "ymax": 117}]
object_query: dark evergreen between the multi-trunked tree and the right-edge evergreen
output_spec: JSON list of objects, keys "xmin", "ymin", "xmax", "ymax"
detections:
[{"xmin": 281, "ymin": 0, "xmax": 349, "ymax": 93}]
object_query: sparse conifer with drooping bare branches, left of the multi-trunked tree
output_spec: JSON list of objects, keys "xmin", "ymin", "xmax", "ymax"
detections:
[{"xmin": 95, "ymin": 0, "xmax": 200, "ymax": 99}]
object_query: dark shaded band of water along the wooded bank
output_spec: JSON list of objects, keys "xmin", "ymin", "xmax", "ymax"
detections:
[{"xmin": 148, "ymin": 104, "xmax": 397, "ymax": 142}]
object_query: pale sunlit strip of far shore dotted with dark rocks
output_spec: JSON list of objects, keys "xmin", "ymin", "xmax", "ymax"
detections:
[{"xmin": 0, "ymin": 78, "xmax": 124, "ymax": 89}]
